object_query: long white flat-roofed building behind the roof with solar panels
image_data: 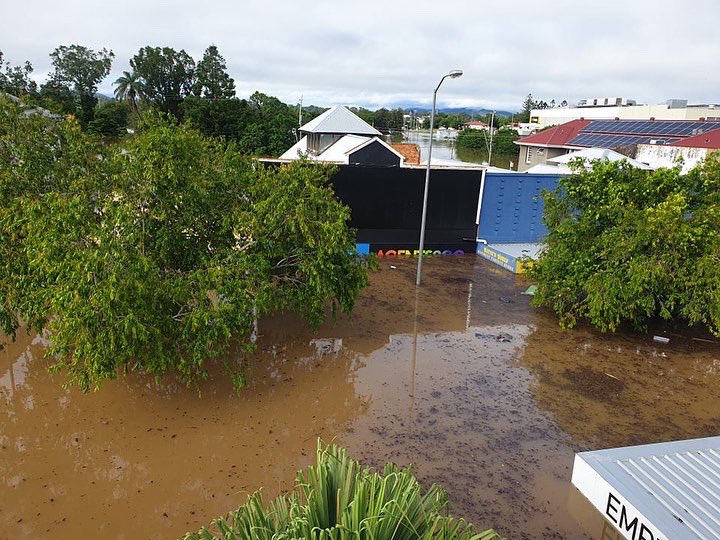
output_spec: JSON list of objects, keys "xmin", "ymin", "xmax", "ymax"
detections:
[{"xmin": 530, "ymin": 98, "xmax": 720, "ymax": 129}]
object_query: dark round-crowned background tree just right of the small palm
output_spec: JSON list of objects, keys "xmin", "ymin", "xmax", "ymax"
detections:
[{"xmin": 130, "ymin": 47, "xmax": 195, "ymax": 118}]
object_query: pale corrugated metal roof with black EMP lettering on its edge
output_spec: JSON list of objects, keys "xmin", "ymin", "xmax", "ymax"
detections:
[{"xmin": 572, "ymin": 437, "xmax": 720, "ymax": 540}]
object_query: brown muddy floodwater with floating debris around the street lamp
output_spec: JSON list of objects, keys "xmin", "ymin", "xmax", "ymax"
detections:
[{"xmin": 0, "ymin": 257, "xmax": 720, "ymax": 539}]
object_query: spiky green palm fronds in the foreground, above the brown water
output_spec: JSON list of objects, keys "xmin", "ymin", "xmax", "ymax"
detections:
[{"xmin": 184, "ymin": 441, "xmax": 500, "ymax": 540}]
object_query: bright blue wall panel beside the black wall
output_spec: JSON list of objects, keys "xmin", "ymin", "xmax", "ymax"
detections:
[{"xmin": 477, "ymin": 173, "xmax": 559, "ymax": 244}]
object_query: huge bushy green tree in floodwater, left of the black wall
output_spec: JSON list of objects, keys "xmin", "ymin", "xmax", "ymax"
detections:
[{"xmin": 0, "ymin": 97, "xmax": 367, "ymax": 389}]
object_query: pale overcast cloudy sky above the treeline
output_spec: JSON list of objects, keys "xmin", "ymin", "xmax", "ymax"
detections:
[{"xmin": 0, "ymin": 0, "xmax": 720, "ymax": 110}]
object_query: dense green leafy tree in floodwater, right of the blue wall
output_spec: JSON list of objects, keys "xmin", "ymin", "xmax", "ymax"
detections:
[{"xmin": 532, "ymin": 154, "xmax": 720, "ymax": 335}]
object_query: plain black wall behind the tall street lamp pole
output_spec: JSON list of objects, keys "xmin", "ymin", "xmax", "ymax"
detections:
[{"xmin": 332, "ymin": 165, "xmax": 482, "ymax": 253}]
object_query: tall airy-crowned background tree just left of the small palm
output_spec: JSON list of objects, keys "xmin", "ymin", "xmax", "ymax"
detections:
[{"xmin": 50, "ymin": 45, "xmax": 115, "ymax": 125}]
